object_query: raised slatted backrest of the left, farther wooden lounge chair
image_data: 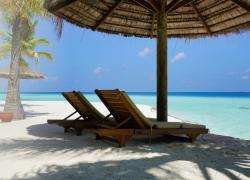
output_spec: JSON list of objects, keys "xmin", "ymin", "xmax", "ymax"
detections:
[{"xmin": 62, "ymin": 91, "xmax": 104, "ymax": 120}]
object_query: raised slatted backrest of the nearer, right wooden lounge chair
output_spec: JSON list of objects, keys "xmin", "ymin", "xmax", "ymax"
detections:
[{"xmin": 95, "ymin": 89, "xmax": 147, "ymax": 128}]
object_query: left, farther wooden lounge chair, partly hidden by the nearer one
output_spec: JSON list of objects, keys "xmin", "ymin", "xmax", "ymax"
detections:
[{"xmin": 47, "ymin": 91, "xmax": 116, "ymax": 135}]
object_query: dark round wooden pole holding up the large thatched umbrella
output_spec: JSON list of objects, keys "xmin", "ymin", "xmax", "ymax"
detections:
[{"xmin": 157, "ymin": 0, "xmax": 168, "ymax": 121}]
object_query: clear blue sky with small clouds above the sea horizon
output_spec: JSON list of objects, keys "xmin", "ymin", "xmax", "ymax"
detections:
[{"xmin": 0, "ymin": 21, "xmax": 250, "ymax": 92}]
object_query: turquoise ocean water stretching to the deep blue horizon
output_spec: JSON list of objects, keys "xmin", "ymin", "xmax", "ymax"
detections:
[{"xmin": 0, "ymin": 93, "xmax": 250, "ymax": 140}]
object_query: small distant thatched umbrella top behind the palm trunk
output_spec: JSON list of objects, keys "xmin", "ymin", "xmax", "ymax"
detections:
[{"xmin": 0, "ymin": 67, "xmax": 45, "ymax": 79}]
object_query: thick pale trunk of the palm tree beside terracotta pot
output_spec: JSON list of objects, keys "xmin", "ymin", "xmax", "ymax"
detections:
[{"xmin": 4, "ymin": 15, "xmax": 29, "ymax": 119}]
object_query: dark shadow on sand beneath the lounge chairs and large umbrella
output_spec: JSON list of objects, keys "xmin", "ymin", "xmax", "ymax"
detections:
[{"xmin": 20, "ymin": 124, "xmax": 250, "ymax": 179}]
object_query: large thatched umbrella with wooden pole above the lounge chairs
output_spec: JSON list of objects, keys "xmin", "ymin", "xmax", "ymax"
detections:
[{"xmin": 45, "ymin": 0, "xmax": 250, "ymax": 121}]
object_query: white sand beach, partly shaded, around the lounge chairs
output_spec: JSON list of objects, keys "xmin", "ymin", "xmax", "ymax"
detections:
[{"xmin": 0, "ymin": 102, "xmax": 250, "ymax": 180}]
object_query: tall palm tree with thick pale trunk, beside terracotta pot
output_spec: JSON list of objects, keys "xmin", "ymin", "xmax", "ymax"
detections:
[{"xmin": 0, "ymin": 0, "xmax": 62, "ymax": 119}]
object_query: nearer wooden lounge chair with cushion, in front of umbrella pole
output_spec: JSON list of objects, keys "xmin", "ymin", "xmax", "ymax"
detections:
[{"xmin": 94, "ymin": 89, "xmax": 208, "ymax": 147}]
